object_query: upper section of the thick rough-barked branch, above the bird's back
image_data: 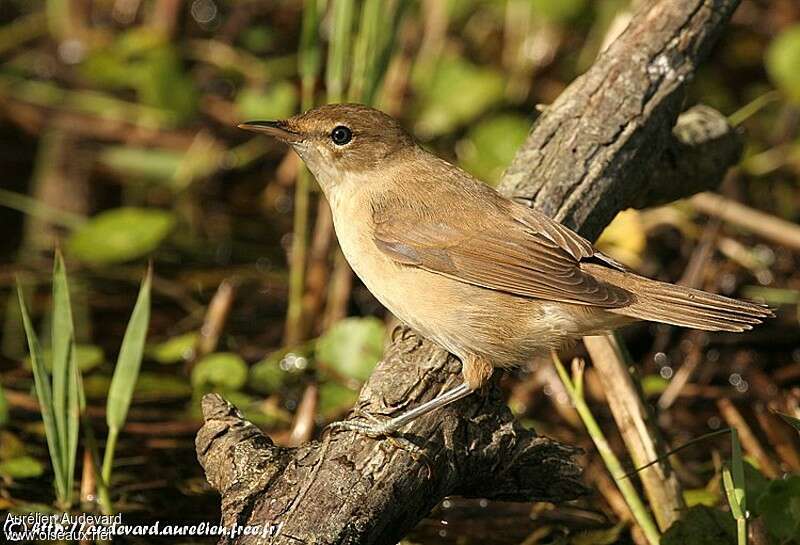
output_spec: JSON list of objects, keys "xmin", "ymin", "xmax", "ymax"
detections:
[{"xmin": 501, "ymin": 0, "xmax": 739, "ymax": 238}]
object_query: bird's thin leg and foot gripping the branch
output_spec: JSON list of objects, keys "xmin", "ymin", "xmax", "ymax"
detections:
[{"xmin": 328, "ymin": 357, "xmax": 493, "ymax": 438}]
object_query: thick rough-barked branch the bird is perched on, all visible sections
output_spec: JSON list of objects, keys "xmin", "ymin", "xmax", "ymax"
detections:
[{"xmin": 197, "ymin": 0, "xmax": 740, "ymax": 544}]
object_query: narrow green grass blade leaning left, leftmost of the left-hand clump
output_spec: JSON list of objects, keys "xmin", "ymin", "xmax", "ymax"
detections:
[{"xmin": 17, "ymin": 282, "xmax": 69, "ymax": 501}]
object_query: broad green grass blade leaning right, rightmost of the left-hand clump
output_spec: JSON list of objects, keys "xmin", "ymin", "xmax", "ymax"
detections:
[{"xmin": 103, "ymin": 267, "xmax": 153, "ymax": 486}]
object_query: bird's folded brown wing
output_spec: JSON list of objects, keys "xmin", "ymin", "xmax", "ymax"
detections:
[{"xmin": 373, "ymin": 196, "xmax": 633, "ymax": 308}]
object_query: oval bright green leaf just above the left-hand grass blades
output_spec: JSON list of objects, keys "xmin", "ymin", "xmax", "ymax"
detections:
[{"xmin": 67, "ymin": 207, "xmax": 175, "ymax": 264}]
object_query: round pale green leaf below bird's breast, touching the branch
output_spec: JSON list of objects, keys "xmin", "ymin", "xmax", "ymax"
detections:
[{"xmin": 317, "ymin": 317, "xmax": 386, "ymax": 381}]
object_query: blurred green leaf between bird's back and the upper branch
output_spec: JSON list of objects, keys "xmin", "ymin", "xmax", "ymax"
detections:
[{"xmin": 456, "ymin": 114, "xmax": 530, "ymax": 186}]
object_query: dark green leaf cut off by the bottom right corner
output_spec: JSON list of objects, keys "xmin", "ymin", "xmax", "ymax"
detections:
[{"xmin": 758, "ymin": 475, "xmax": 800, "ymax": 543}]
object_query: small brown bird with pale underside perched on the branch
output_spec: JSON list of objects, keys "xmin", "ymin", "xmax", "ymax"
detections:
[{"xmin": 240, "ymin": 104, "xmax": 772, "ymax": 436}]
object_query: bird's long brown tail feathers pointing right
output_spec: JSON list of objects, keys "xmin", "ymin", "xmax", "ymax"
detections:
[{"xmin": 582, "ymin": 264, "xmax": 774, "ymax": 332}]
